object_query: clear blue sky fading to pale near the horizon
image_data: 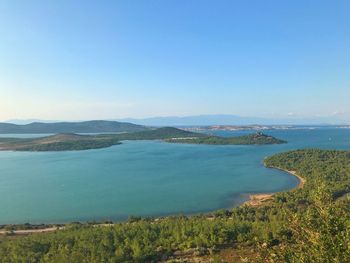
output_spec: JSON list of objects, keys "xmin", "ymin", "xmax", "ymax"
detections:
[{"xmin": 0, "ymin": 0, "xmax": 350, "ymax": 123}]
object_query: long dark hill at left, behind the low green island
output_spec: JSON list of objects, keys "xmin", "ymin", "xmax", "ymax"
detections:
[{"xmin": 0, "ymin": 121, "xmax": 149, "ymax": 134}]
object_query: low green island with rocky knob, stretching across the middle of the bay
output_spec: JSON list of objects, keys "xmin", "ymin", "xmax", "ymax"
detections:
[{"xmin": 0, "ymin": 127, "xmax": 285, "ymax": 152}]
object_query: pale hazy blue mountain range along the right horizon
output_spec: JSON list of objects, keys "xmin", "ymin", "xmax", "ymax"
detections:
[{"xmin": 119, "ymin": 114, "xmax": 346, "ymax": 126}]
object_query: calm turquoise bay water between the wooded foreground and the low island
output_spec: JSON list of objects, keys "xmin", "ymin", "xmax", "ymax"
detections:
[{"xmin": 0, "ymin": 128, "xmax": 350, "ymax": 224}]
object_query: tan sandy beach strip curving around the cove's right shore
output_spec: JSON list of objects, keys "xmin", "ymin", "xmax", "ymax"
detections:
[{"xmin": 241, "ymin": 167, "xmax": 306, "ymax": 207}]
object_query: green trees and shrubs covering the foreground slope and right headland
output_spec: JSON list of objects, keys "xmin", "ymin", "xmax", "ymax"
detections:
[{"xmin": 0, "ymin": 150, "xmax": 350, "ymax": 262}]
